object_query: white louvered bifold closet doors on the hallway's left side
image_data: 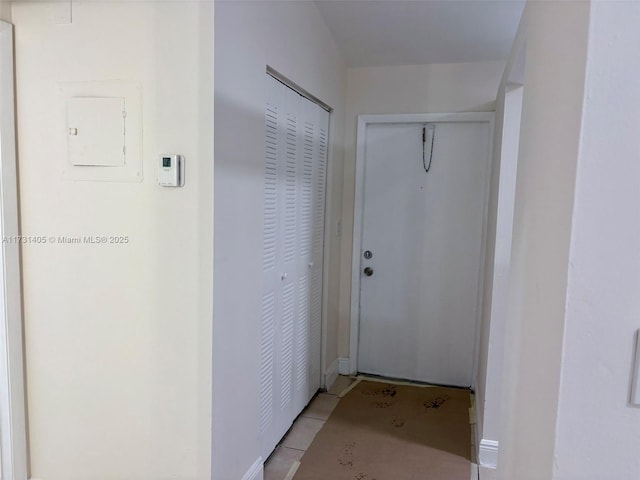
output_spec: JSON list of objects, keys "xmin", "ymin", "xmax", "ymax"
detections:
[{"xmin": 260, "ymin": 75, "xmax": 329, "ymax": 458}]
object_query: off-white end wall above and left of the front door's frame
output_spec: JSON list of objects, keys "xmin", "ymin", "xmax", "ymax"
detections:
[{"xmin": 339, "ymin": 62, "xmax": 505, "ymax": 357}]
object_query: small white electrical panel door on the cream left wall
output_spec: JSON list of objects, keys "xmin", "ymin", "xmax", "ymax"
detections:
[{"xmin": 67, "ymin": 97, "xmax": 126, "ymax": 167}]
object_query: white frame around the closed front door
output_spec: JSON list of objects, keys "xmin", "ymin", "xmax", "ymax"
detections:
[{"xmin": 349, "ymin": 112, "xmax": 494, "ymax": 382}]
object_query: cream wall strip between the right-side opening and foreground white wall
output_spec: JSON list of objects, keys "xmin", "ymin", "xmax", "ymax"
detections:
[{"xmin": 498, "ymin": 2, "xmax": 592, "ymax": 480}]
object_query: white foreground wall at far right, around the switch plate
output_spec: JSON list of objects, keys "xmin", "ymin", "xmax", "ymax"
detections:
[{"xmin": 553, "ymin": 2, "xmax": 640, "ymax": 480}]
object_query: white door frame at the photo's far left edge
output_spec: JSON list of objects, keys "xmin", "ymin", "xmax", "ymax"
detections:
[{"xmin": 0, "ymin": 21, "xmax": 28, "ymax": 480}]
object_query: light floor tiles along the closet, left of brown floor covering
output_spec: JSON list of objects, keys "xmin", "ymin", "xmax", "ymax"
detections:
[{"xmin": 264, "ymin": 375, "xmax": 355, "ymax": 480}]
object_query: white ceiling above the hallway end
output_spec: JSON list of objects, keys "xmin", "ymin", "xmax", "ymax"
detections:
[{"xmin": 316, "ymin": 0, "xmax": 524, "ymax": 67}]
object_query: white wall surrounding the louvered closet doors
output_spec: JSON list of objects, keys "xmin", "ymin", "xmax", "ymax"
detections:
[{"xmin": 213, "ymin": 1, "xmax": 346, "ymax": 480}]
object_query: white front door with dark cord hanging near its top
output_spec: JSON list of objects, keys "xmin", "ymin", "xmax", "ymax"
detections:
[{"xmin": 358, "ymin": 122, "xmax": 491, "ymax": 386}]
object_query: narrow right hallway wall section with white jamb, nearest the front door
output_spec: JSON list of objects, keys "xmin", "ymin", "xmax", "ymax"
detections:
[{"xmin": 476, "ymin": 20, "xmax": 525, "ymax": 468}]
